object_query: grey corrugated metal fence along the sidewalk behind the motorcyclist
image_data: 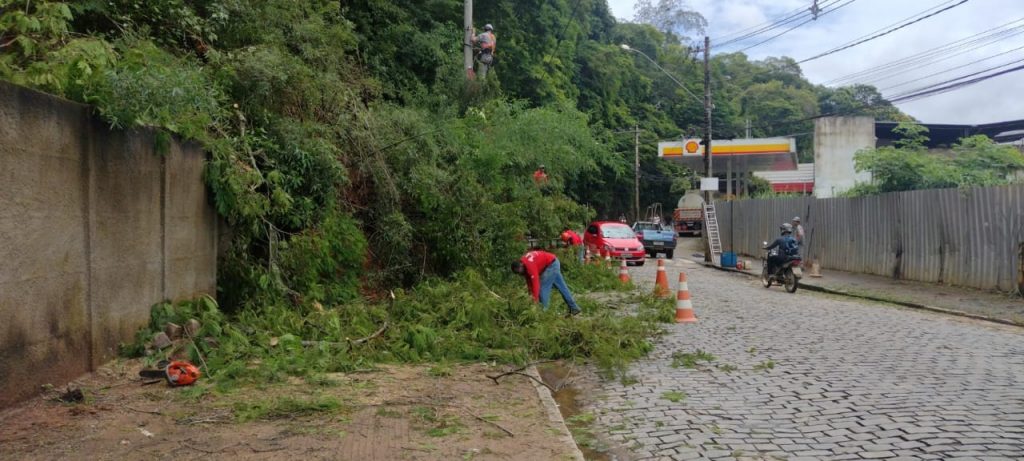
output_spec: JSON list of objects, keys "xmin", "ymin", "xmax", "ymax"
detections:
[{"xmin": 716, "ymin": 185, "xmax": 1024, "ymax": 291}]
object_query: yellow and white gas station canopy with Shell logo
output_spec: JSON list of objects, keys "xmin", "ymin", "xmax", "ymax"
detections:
[{"xmin": 657, "ymin": 137, "xmax": 797, "ymax": 173}]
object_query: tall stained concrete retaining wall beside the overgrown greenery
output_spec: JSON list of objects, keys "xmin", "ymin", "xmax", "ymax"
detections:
[{"xmin": 0, "ymin": 82, "xmax": 217, "ymax": 407}]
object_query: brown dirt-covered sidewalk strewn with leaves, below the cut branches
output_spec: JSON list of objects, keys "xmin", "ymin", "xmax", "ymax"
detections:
[{"xmin": 0, "ymin": 361, "xmax": 572, "ymax": 460}]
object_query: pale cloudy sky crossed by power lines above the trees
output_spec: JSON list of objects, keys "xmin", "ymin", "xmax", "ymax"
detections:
[{"xmin": 608, "ymin": 0, "xmax": 1024, "ymax": 124}]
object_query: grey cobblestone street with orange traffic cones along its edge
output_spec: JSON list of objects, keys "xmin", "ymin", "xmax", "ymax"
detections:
[{"xmin": 590, "ymin": 255, "xmax": 1024, "ymax": 461}]
